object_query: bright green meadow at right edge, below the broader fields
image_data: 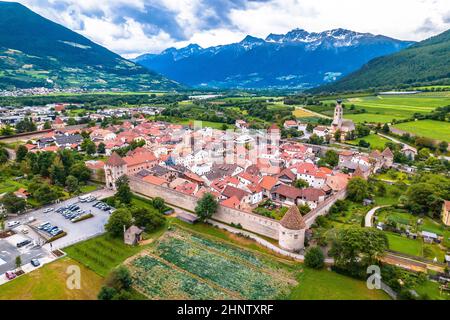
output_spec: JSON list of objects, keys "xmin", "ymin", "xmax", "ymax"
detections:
[{"xmin": 394, "ymin": 120, "xmax": 450, "ymax": 142}]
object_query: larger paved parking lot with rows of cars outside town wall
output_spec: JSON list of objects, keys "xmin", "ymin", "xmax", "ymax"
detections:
[{"xmin": 7, "ymin": 189, "xmax": 113, "ymax": 251}]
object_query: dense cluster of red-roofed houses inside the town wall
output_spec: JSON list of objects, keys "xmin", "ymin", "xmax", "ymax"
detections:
[{"xmin": 101, "ymin": 117, "xmax": 393, "ymax": 218}]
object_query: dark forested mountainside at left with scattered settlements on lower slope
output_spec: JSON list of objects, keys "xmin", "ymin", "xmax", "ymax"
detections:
[{"xmin": 0, "ymin": 2, "xmax": 181, "ymax": 90}]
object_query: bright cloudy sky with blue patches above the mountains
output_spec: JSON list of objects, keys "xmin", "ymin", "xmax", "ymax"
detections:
[{"xmin": 14, "ymin": 0, "xmax": 450, "ymax": 57}]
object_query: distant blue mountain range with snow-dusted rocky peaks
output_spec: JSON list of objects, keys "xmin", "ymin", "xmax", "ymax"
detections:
[{"xmin": 133, "ymin": 29, "xmax": 414, "ymax": 89}]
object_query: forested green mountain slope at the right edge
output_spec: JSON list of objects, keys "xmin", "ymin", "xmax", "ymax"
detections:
[{"xmin": 313, "ymin": 30, "xmax": 450, "ymax": 92}]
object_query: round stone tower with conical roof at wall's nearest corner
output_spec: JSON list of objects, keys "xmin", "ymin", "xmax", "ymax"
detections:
[{"xmin": 278, "ymin": 205, "xmax": 306, "ymax": 252}]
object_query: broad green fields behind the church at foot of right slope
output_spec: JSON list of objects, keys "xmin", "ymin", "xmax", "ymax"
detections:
[{"xmin": 316, "ymin": 92, "xmax": 450, "ymax": 123}]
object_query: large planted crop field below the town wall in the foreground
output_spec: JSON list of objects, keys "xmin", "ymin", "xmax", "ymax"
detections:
[{"xmin": 129, "ymin": 229, "xmax": 297, "ymax": 300}]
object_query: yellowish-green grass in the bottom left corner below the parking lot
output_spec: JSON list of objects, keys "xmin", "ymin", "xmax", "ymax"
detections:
[{"xmin": 0, "ymin": 257, "xmax": 103, "ymax": 300}]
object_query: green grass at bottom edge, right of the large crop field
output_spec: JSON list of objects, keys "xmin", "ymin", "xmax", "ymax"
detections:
[{"xmin": 289, "ymin": 268, "xmax": 390, "ymax": 300}]
